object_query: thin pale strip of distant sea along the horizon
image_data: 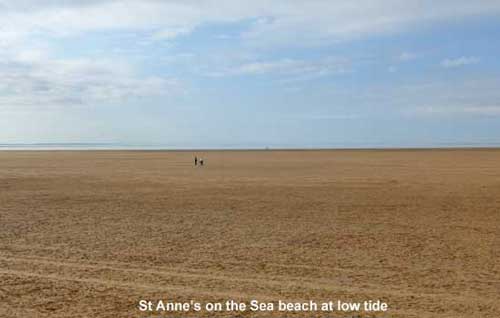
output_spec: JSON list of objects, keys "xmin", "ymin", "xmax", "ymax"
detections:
[{"xmin": 0, "ymin": 141, "xmax": 500, "ymax": 151}]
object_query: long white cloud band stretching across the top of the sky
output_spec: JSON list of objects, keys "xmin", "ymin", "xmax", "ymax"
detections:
[{"xmin": 0, "ymin": 0, "xmax": 500, "ymax": 46}]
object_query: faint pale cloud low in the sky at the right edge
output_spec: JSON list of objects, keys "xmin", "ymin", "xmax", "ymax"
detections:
[{"xmin": 327, "ymin": 76, "xmax": 500, "ymax": 118}]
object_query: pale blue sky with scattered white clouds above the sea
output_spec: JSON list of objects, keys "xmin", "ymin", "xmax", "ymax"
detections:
[{"xmin": 0, "ymin": 0, "xmax": 500, "ymax": 148}]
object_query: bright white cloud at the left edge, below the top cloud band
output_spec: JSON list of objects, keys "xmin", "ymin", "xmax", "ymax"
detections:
[{"xmin": 0, "ymin": 52, "xmax": 179, "ymax": 109}]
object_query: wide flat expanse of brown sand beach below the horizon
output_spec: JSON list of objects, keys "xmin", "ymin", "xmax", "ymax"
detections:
[{"xmin": 0, "ymin": 149, "xmax": 500, "ymax": 318}]
